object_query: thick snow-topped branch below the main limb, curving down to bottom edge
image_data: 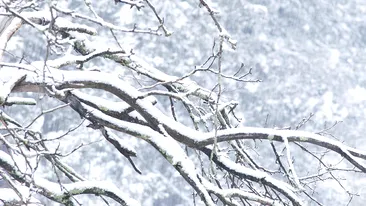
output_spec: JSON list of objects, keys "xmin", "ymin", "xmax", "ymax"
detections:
[{"xmin": 60, "ymin": 92, "xmax": 214, "ymax": 205}]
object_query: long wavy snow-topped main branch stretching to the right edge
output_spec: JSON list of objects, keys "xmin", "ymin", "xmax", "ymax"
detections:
[{"xmin": 5, "ymin": 66, "xmax": 366, "ymax": 171}]
